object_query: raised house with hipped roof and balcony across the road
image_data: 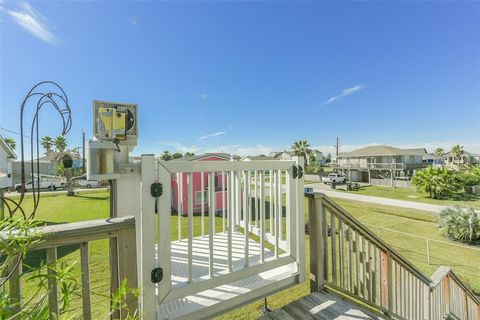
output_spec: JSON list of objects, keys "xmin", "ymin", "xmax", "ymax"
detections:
[{"xmin": 333, "ymin": 145, "xmax": 428, "ymax": 187}]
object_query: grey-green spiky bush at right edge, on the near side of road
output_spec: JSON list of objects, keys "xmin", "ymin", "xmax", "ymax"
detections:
[{"xmin": 438, "ymin": 206, "xmax": 480, "ymax": 244}]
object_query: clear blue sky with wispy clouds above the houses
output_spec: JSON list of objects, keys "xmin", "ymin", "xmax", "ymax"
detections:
[{"xmin": 0, "ymin": 0, "xmax": 480, "ymax": 154}]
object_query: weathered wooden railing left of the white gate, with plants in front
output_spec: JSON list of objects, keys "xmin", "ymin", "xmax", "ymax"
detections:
[{"xmin": 5, "ymin": 217, "xmax": 138, "ymax": 320}]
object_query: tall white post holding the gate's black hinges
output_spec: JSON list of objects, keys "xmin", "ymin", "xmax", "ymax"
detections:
[{"xmin": 141, "ymin": 154, "xmax": 157, "ymax": 320}]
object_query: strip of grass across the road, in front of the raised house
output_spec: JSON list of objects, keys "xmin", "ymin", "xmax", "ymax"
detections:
[{"xmin": 337, "ymin": 186, "xmax": 480, "ymax": 209}]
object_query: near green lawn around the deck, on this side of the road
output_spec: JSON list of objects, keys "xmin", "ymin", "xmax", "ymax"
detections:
[{"xmin": 10, "ymin": 191, "xmax": 480, "ymax": 320}]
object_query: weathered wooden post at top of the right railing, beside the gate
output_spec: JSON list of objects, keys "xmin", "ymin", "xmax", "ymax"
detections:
[{"xmin": 307, "ymin": 193, "xmax": 326, "ymax": 292}]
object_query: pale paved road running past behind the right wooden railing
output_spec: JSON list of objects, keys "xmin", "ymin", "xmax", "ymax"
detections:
[{"xmin": 306, "ymin": 183, "xmax": 446, "ymax": 213}]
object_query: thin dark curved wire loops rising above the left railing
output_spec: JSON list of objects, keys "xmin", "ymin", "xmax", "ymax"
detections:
[{"xmin": 0, "ymin": 81, "xmax": 72, "ymax": 286}]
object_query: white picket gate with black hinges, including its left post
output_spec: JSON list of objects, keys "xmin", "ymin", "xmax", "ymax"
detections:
[{"xmin": 131, "ymin": 155, "xmax": 305, "ymax": 319}]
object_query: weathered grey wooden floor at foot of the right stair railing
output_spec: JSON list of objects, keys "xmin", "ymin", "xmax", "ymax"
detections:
[{"xmin": 261, "ymin": 292, "xmax": 382, "ymax": 320}]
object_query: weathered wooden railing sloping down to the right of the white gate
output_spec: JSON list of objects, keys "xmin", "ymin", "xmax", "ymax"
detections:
[{"xmin": 307, "ymin": 193, "xmax": 480, "ymax": 320}]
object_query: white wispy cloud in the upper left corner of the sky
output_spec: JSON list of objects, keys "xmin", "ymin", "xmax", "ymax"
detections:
[{"xmin": 2, "ymin": 2, "xmax": 59, "ymax": 45}]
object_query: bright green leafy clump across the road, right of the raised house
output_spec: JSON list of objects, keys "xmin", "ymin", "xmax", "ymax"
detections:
[{"xmin": 412, "ymin": 167, "xmax": 463, "ymax": 199}]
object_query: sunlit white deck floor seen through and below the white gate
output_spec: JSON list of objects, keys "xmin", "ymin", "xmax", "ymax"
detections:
[{"xmin": 157, "ymin": 232, "xmax": 295, "ymax": 320}]
